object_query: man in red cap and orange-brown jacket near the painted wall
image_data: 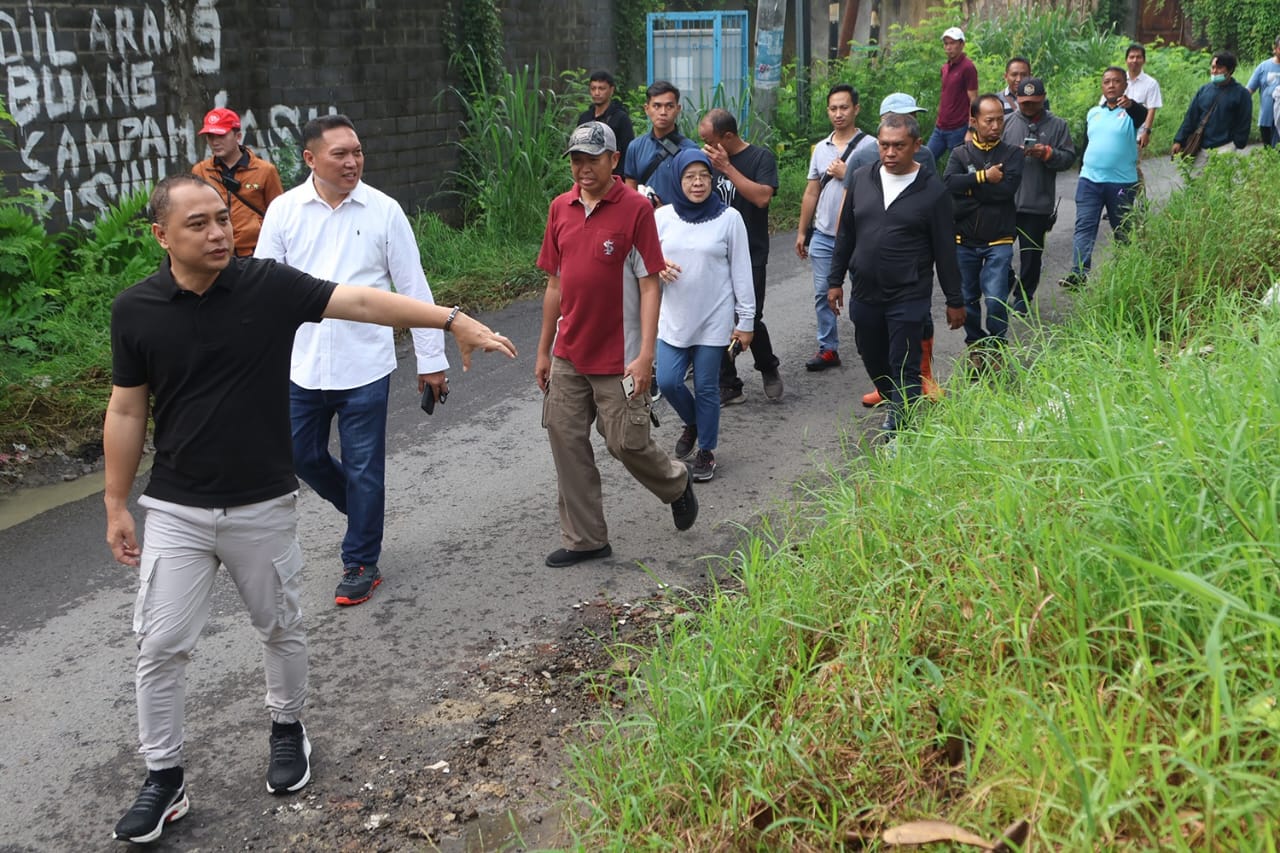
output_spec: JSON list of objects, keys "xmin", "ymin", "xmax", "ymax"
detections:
[{"xmin": 191, "ymin": 106, "xmax": 284, "ymax": 257}]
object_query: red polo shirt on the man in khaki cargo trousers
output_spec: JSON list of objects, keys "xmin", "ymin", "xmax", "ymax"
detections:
[{"xmin": 538, "ymin": 177, "xmax": 666, "ymax": 375}]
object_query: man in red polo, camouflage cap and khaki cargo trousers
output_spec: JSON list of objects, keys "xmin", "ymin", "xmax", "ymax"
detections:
[{"xmin": 534, "ymin": 122, "xmax": 698, "ymax": 567}]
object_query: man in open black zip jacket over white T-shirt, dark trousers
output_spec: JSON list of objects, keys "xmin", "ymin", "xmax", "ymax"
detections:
[{"xmin": 827, "ymin": 113, "xmax": 965, "ymax": 430}]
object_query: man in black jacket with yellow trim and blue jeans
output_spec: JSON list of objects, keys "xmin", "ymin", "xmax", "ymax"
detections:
[{"xmin": 942, "ymin": 95, "xmax": 1023, "ymax": 347}]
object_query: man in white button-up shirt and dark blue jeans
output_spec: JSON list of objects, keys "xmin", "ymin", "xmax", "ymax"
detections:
[{"xmin": 255, "ymin": 115, "xmax": 449, "ymax": 605}]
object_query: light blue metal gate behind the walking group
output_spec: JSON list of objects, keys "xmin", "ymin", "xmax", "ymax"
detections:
[{"xmin": 645, "ymin": 12, "xmax": 751, "ymax": 133}]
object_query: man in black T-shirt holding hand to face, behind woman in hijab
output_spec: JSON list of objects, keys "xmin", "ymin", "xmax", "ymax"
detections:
[{"xmin": 698, "ymin": 108, "xmax": 782, "ymax": 406}]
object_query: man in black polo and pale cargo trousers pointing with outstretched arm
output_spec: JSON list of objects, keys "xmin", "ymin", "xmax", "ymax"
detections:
[{"xmin": 102, "ymin": 174, "xmax": 515, "ymax": 844}]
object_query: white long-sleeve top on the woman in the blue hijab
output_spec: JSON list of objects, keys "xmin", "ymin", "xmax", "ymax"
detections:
[{"xmin": 654, "ymin": 205, "xmax": 755, "ymax": 347}]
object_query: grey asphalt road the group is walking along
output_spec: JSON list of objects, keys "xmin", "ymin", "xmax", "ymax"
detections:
[{"xmin": 0, "ymin": 154, "xmax": 1169, "ymax": 850}]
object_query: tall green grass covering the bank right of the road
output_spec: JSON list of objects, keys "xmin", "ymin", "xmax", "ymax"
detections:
[{"xmin": 572, "ymin": 156, "xmax": 1280, "ymax": 850}]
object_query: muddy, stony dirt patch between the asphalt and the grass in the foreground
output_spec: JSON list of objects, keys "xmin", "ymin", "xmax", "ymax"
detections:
[{"xmin": 231, "ymin": 596, "xmax": 690, "ymax": 853}]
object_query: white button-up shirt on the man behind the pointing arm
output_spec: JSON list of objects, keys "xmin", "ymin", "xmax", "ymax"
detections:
[{"xmin": 253, "ymin": 178, "xmax": 449, "ymax": 391}]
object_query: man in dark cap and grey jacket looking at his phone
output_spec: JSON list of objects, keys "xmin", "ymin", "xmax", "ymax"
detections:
[{"xmin": 1004, "ymin": 77, "xmax": 1075, "ymax": 313}]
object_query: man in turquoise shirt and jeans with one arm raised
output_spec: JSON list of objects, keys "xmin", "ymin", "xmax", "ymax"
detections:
[{"xmin": 1059, "ymin": 65, "xmax": 1147, "ymax": 289}]
